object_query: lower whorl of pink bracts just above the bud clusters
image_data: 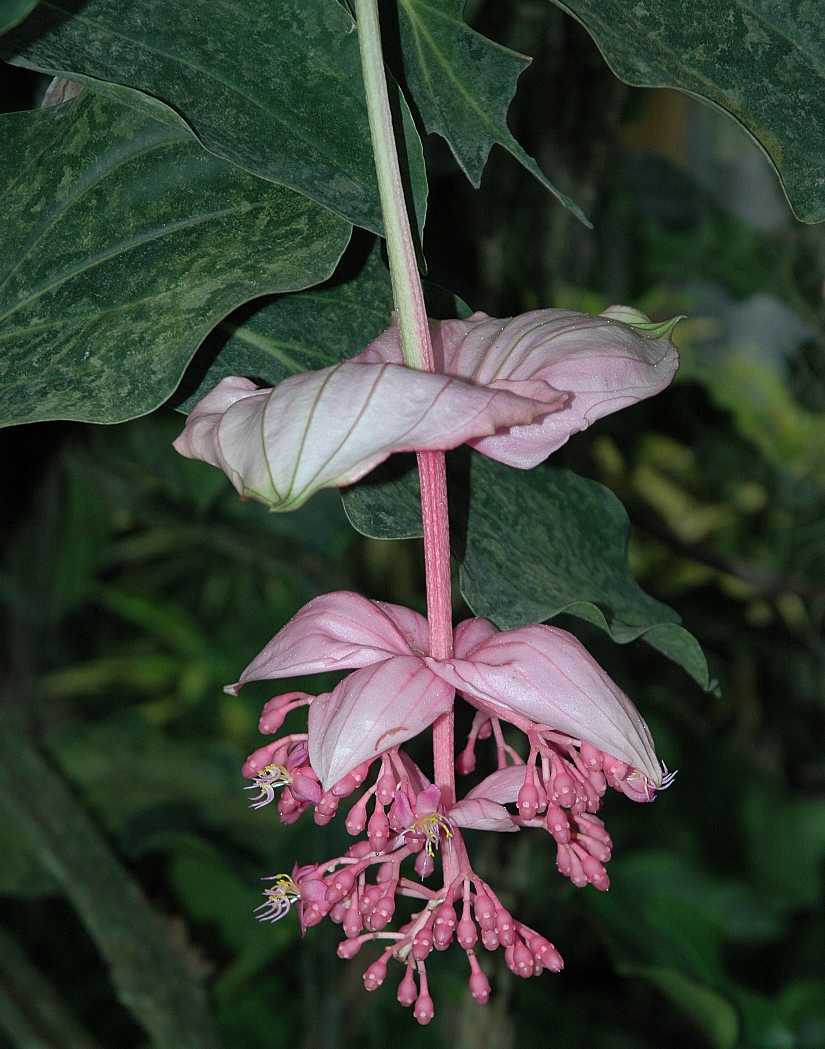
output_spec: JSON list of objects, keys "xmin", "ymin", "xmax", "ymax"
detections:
[{"xmin": 227, "ymin": 592, "xmax": 662, "ymax": 788}]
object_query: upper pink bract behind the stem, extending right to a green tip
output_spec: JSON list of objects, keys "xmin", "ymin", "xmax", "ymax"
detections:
[{"xmin": 355, "ymin": 306, "xmax": 678, "ymax": 469}]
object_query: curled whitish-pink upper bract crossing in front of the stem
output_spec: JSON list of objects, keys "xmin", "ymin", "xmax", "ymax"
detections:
[{"xmin": 174, "ymin": 362, "xmax": 566, "ymax": 510}]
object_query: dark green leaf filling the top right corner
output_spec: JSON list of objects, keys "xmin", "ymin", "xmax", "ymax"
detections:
[{"xmin": 553, "ymin": 0, "xmax": 825, "ymax": 222}]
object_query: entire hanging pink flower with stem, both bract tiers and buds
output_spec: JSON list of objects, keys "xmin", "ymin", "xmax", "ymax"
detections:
[{"xmin": 170, "ymin": 0, "xmax": 677, "ymax": 1024}]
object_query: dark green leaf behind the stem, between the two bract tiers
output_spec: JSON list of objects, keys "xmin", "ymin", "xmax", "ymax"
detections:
[{"xmin": 343, "ymin": 454, "xmax": 713, "ymax": 689}]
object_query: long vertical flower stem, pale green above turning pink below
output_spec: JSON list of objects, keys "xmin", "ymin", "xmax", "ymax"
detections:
[{"xmin": 355, "ymin": 0, "xmax": 464, "ymax": 884}]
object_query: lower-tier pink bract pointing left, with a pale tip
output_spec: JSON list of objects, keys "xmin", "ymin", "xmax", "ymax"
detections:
[{"xmin": 225, "ymin": 591, "xmax": 429, "ymax": 695}]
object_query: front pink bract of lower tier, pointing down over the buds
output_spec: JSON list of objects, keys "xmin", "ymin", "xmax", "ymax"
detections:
[{"xmin": 309, "ymin": 656, "xmax": 453, "ymax": 790}]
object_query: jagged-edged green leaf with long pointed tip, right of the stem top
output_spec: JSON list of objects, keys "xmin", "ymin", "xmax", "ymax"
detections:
[{"xmin": 399, "ymin": 0, "xmax": 590, "ymax": 226}]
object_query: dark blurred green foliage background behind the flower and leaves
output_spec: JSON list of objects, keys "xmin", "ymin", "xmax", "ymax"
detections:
[{"xmin": 0, "ymin": 0, "xmax": 825, "ymax": 1049}]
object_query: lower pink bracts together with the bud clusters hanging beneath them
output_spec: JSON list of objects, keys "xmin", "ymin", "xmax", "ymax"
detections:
[{"xmin": 227, "ymin": 592, "xmax": 669, "ymax": 1022}]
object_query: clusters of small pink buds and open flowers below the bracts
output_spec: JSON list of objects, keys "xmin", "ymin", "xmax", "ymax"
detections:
[{"xmin": 244, "ymin": 679, "xmax": 672, "ymax": 1024}]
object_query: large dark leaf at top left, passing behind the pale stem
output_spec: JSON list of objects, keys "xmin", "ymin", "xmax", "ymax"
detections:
[{"xmin": 0, "ymin": 0, "xmax": 426, "ymax": 231}]
